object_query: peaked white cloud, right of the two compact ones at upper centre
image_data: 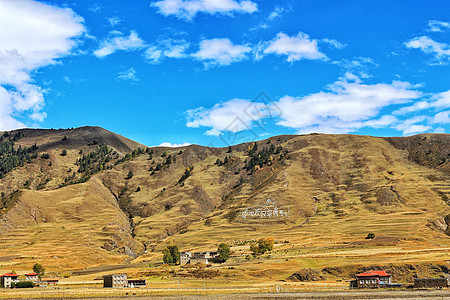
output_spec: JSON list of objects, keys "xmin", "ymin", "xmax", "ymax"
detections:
[{"xmin": 255, "ymin": 32, "xmax": 327, "ymax": 63}]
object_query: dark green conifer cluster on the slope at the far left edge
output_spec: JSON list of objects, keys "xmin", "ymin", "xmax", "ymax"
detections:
[{"xmin": 0, "ymin": 132, "xmax": 38, "ymax": 178}]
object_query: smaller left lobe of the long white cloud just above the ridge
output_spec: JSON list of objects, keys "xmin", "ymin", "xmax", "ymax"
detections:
[{"xmin": 186, "ymin": 99, "xmax": 268, "ymax": 136}]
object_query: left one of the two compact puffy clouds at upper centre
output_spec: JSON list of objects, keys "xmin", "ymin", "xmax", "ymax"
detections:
[{"xmin": 192, "ymin": 38, "xmax": 252, "ymax": 67}]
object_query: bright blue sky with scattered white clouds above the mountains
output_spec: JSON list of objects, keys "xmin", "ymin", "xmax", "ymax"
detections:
[{"xmin": 0, "ymin": 0, "xmax": 450, "ymax": 147}]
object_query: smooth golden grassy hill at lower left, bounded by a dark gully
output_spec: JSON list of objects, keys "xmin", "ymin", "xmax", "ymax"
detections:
[{"xmin": 0, "ymin": 179, "xmax": 138, "ymax": 271}]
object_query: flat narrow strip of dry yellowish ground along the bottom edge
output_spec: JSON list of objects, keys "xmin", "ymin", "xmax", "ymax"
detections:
[{"xmin": 0, "ymin": 288, "xmax": 450, "ymax": 300}]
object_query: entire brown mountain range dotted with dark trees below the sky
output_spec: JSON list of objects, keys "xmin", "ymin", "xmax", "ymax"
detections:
[{"xmin": 0, "ymin": 127, "xmax": 450, "ymax": 279}]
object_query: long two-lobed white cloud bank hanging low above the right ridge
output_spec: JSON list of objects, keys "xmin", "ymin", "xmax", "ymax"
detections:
[{"xmin": 186, "ymin": 76, "xmax": 427, "ymax": 135}]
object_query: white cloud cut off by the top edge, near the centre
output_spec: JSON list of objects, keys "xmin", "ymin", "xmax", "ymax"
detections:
[{"xmin": 151, "ymin": 0, "xmax": 258, "ymax": 20}]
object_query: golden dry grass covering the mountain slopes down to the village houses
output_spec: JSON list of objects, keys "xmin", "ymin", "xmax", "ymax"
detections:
[{"xmin": 0, "ymin": 132, "xmax": 450, "ymax": 286}]
